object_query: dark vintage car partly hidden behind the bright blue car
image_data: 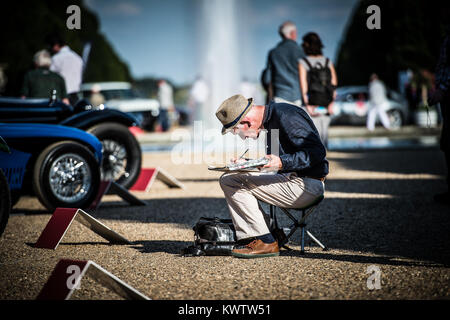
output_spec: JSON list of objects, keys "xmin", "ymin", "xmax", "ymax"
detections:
[{"xmin": 0, "ymin": 97, "xmax": 142, "ymax": 188}]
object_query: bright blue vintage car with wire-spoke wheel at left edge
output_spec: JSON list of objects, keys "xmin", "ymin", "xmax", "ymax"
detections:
[{"xmin": 0, "ymin": 123, "xmax": 102, "ymax": 215}]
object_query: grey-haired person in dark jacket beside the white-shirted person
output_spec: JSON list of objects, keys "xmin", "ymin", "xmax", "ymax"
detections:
[{"xmin": 22, "ymin": 50, "xmax": 69, "ymax": 104}]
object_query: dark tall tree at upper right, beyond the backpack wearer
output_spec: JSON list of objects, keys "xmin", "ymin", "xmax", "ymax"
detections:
[{"xmin": 336, "ymin": 0, "xmax": 446, "ymax": 88}]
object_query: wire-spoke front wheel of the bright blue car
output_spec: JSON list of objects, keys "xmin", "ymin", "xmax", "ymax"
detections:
[{"xmin": 33, "ymin": 141, "xmax": 100, "ymax": 211}]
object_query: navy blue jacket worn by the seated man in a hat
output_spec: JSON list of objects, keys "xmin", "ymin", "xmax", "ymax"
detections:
[{"xmin": 263, "ymin": 102, "xmax": 328, "ymax": 178}]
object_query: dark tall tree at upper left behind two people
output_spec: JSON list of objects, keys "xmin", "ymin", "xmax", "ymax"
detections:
[{"xmin": 0, "ymin": 0, "xmax": 132, "ymax": 96}]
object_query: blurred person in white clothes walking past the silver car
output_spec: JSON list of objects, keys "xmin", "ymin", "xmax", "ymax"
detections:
[{"xmin": 366, "ymin": 73, "xmax": 390, "ymax": 131}]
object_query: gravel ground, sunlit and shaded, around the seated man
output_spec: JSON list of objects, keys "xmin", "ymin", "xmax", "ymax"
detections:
[{"xmin": 0, "ymin": 149, "xmax": 450, "ymax": 300}]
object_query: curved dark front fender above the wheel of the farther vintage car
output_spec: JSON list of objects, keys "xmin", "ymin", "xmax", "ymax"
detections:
[{"xmin": 59, "ymin": 109, "xmax": 139, "ymax": 130}]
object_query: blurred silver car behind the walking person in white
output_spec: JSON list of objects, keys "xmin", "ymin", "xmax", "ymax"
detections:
[{"xmin": 331, "ymin": 86, "xmax": 409, "ymax": 128}]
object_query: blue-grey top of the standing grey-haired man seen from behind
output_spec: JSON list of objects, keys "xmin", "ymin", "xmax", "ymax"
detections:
[{"xmin": 263, "ymin": 39, "xmax": 304, "ymax": 101}]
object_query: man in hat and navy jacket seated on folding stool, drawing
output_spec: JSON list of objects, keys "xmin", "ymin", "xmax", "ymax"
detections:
[{"xmin": 216, "ymin": 95, "xmax": 328, "ymax": 258}]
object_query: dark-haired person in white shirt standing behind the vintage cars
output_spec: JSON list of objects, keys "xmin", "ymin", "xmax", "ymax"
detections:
[{"xmin": 47, "ymin": 35, "xmax": 83, "ymax": 105}]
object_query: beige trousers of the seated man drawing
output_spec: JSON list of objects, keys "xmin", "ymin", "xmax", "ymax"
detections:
[{"xmin": 219, "ymin": 172, "xmax": 325, "ymax": 240}]
